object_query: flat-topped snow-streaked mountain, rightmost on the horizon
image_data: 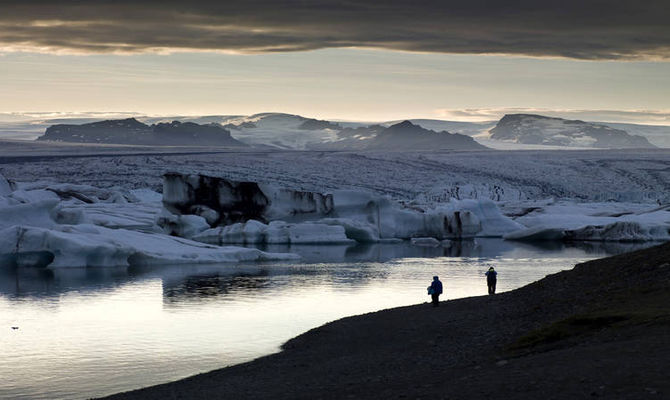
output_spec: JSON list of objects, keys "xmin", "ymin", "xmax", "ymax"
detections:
[{"xmin": 489, "ymin": 114, "xmax": 655, "ymax": 148}]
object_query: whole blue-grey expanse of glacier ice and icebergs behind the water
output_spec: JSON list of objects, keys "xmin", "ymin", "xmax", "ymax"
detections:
[{"xmin": 0, "ymin": 143, "xmax": 670, "ymax": 268}]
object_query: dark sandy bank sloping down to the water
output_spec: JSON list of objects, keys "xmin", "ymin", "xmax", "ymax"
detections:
[{"xmin": 103, "ymin": 243, "xmax": 670, "ymax": 399}]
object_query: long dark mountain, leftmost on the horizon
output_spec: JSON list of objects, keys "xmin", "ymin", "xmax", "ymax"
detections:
[{"xmin": 37, "ymin": 118, "xmax": 246, "ymax": 146}]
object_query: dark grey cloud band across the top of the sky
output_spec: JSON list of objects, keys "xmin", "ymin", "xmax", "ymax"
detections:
[{"xmin": 0, "ymin": 0, "xmax": 670, "ymax": 59}]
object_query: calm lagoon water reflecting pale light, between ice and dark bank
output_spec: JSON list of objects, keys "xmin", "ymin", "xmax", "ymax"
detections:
[{"xmin": 0, "ymin": 239, "xmax": 652, "ymax": 399}]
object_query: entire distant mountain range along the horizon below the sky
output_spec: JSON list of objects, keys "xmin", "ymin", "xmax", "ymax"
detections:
[{"xmin": 28, "ymin": 112, "xmax": 670, "ymax": 150}]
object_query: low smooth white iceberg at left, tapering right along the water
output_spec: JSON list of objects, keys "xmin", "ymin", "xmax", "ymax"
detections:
[{"xmin": 0, "ymin": 224, "xmax": 299, "ymax": 268}]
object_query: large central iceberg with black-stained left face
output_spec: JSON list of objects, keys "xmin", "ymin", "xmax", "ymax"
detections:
[{"xmin": 163, "ymin": 172, "xmax": 523, "ymax": 243}]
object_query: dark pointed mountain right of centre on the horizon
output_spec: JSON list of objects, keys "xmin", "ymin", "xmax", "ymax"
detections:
[{"xmin": 312, "ymin": 121, "xmax": 487, "ymax": 151}]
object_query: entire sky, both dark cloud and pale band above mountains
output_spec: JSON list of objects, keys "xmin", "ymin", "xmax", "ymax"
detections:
[{"xmin": 0, "ymin": 0, "xmax": 670, "ymax": 125}]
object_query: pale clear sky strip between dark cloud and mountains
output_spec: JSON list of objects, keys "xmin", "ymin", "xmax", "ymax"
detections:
[{"xmin": 0, "ymin": 49, "xmax": 670, "ymax": 125}]
